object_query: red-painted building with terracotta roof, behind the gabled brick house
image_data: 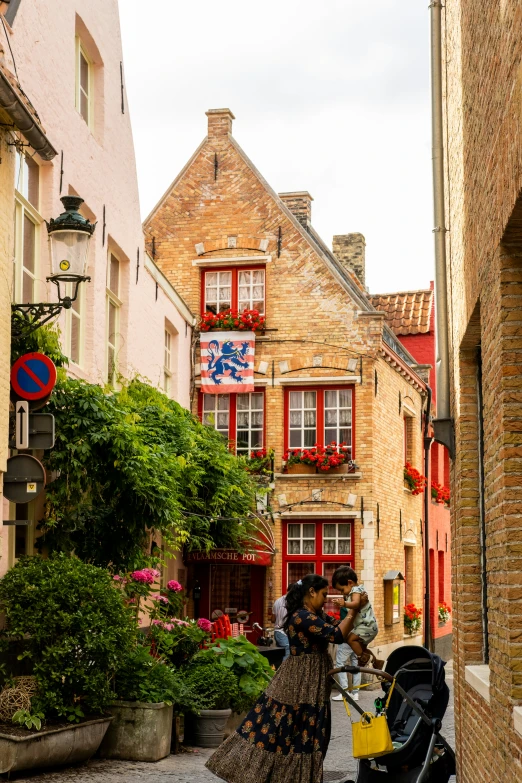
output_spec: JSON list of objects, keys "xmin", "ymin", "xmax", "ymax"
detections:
[{"xmin": 370, "ymin": 283, "xmax": 453, "ymax": 659}]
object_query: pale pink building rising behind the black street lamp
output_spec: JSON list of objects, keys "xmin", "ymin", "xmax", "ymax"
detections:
[{"xmin": 0, "ymin": 0, "xmax": 194, "ymax": 572}]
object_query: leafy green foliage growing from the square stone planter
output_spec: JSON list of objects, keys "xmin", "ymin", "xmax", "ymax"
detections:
[{"xmin": 115, "ymin": 645, "xmax": 193, "ymax": 712}]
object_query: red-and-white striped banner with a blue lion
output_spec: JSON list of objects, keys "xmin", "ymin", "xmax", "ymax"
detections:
[{"xmin": 200, "ymin": 332, "xmax": 256, "ymax": 394}]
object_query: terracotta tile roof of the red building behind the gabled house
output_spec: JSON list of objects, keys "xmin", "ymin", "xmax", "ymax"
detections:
[{"xmin": 369, "ymin": 291, "xmax": 433, "ymax": 334}]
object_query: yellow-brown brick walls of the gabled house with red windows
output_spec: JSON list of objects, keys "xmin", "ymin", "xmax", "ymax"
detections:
[{"xmin": 145, "ymin": 110, "xmax": 425, "ymax": 653}]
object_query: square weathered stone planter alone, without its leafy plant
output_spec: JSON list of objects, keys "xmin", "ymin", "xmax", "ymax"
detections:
[{"xmin": 99, "ymin": 701, "xmax": 173, "ymax": 761}]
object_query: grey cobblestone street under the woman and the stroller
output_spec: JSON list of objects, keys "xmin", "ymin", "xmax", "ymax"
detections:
[{"xmin": 11, "ymin": 663, "xmax": 455, "ymax": 783}]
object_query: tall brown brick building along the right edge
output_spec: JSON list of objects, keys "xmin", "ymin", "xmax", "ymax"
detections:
[{"xmin": 442, "ymin": 0, "xmax": 522, "ymax": 783}]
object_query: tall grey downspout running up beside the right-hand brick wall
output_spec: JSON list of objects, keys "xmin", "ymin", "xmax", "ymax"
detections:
[{"xmin": 429, "ymin": 0, "xmax": 455, "ymax": 459}]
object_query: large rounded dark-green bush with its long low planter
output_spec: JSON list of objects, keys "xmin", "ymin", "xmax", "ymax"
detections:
[{"xmin": 0, "ymin": 555, "xmax": 134, "ymax": 772}]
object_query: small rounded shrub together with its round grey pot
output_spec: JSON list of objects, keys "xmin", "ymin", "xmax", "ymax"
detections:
[{"xmin": 184, "ymin": 656, "xmax": 239, "ymax": 748}]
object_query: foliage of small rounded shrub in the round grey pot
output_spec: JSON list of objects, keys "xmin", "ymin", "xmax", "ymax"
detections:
[{"xmin": 183, "ymin": 658, "xmax": 239, "ymax": 710}]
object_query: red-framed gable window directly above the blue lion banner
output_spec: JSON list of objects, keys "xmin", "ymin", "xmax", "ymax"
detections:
[{"xmin": 202, "ymin": 268, "xmax": 265, "ymax": 315}]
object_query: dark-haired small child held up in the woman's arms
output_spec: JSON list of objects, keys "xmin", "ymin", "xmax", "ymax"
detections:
[{"xmin": 332, "ymin": 566, "xmax": 384, "ymax": 669}]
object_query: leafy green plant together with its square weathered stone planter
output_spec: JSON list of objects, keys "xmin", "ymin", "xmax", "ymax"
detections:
[{"xmin": 100, "ymin": 644, "xmax": 187, "ymax": 761}]
